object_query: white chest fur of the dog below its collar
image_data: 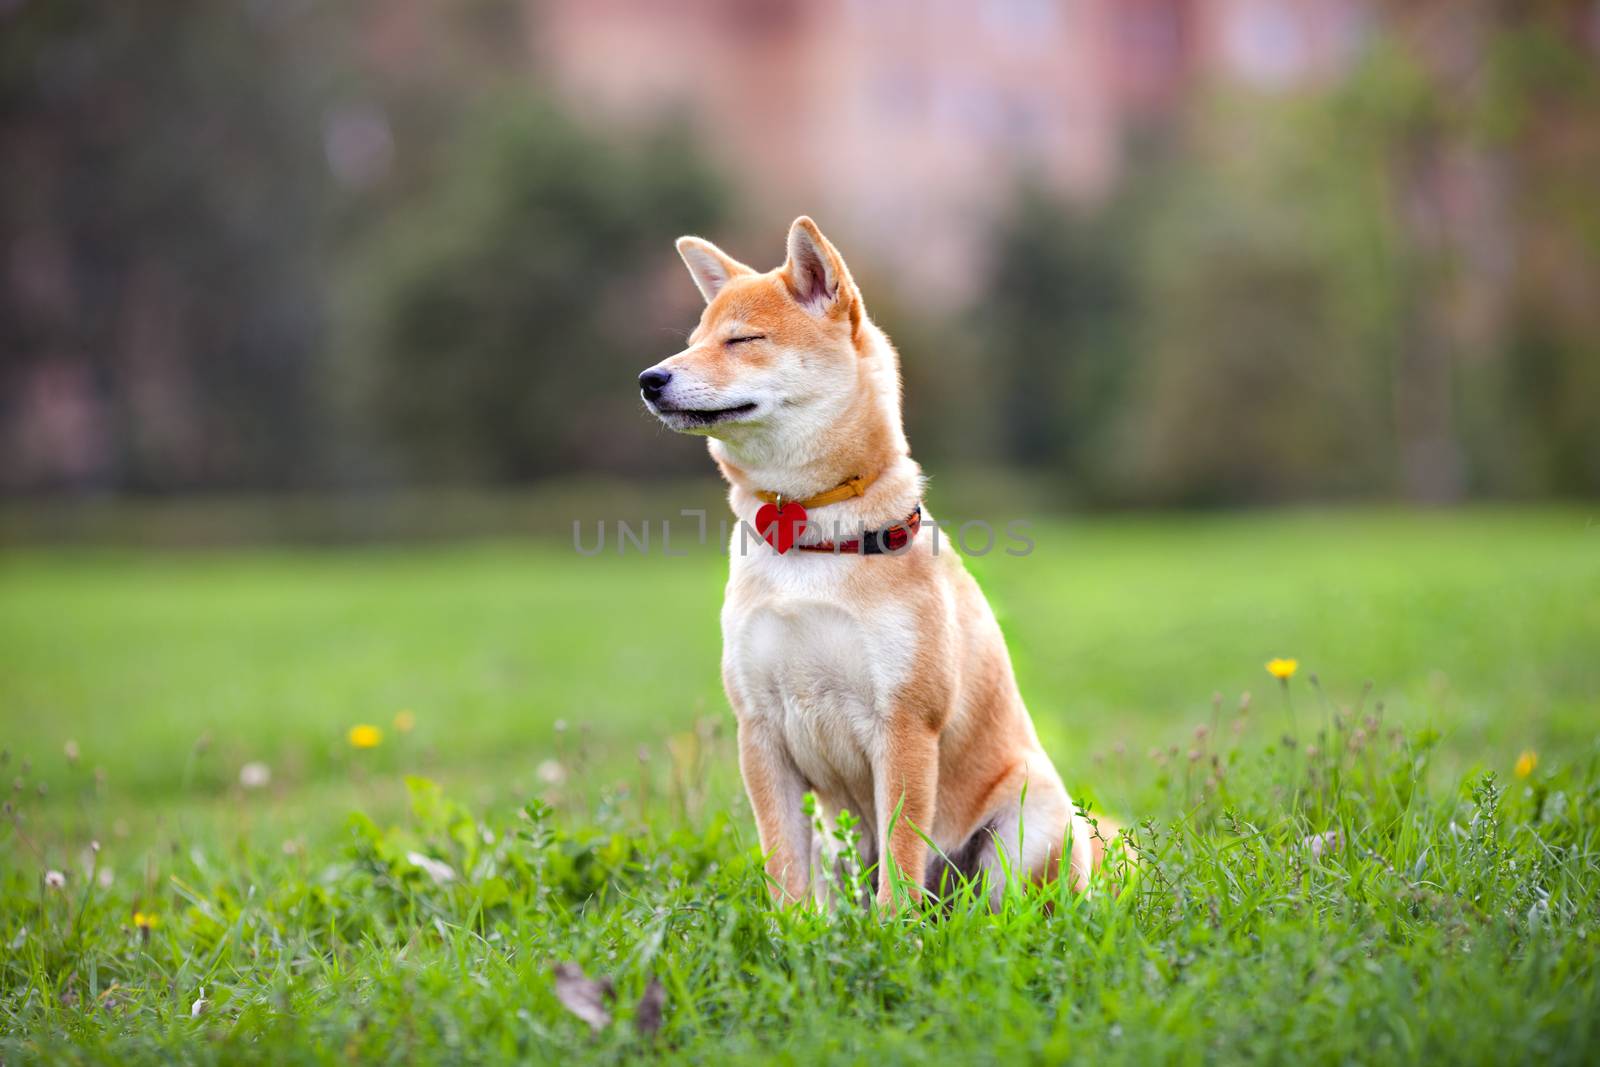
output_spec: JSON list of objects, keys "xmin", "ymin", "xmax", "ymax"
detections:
[{"xmin": 722, "ymin": 544, "xmax": 915, "ymax": 814}]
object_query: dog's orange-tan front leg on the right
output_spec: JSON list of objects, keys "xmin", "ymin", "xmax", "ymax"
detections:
[{"xmin": 874, "ymin": 713, "xmax": 939, "ymax": 907}]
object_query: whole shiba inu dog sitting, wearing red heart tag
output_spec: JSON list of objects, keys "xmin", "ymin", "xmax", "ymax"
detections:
[{"xmin": 638, "ymin": 218, "xmax": 1110, "ymax": 904}]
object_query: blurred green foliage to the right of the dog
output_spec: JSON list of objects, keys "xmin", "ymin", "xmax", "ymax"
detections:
[{"xmin": 971, "ymin": 3, "xmax": 1600, "ymax": 504}]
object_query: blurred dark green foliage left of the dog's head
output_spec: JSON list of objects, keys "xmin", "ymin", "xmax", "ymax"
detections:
[{"xmin": 0, "ymin": 0, "xmax": 726, "ymax": 491}]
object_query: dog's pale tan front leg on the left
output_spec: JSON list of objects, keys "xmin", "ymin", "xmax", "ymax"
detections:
[{"xmin": 739, "ymin": 715, "xmax": 811, "ymax": 905}]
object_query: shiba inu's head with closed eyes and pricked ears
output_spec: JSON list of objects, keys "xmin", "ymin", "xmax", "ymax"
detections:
[{"xmin": 638, "ymin": 216, "xmax": 864, "ymax": 446}]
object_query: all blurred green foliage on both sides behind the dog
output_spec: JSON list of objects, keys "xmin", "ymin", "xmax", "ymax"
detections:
[{"xmin": 0, "ymin": 0, "xmax": 1600, "ymax": 506}]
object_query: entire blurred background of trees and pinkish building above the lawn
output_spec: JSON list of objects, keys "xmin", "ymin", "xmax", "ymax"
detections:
[{"xmin": 9, "ymin": 0, "xmax": 1600, "ymax": 506}]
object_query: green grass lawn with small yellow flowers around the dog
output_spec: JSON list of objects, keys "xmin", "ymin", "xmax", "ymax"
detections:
[{"xmin": 0, "ymin": 510, "xmax": 1600, "ymax": 1064}]
